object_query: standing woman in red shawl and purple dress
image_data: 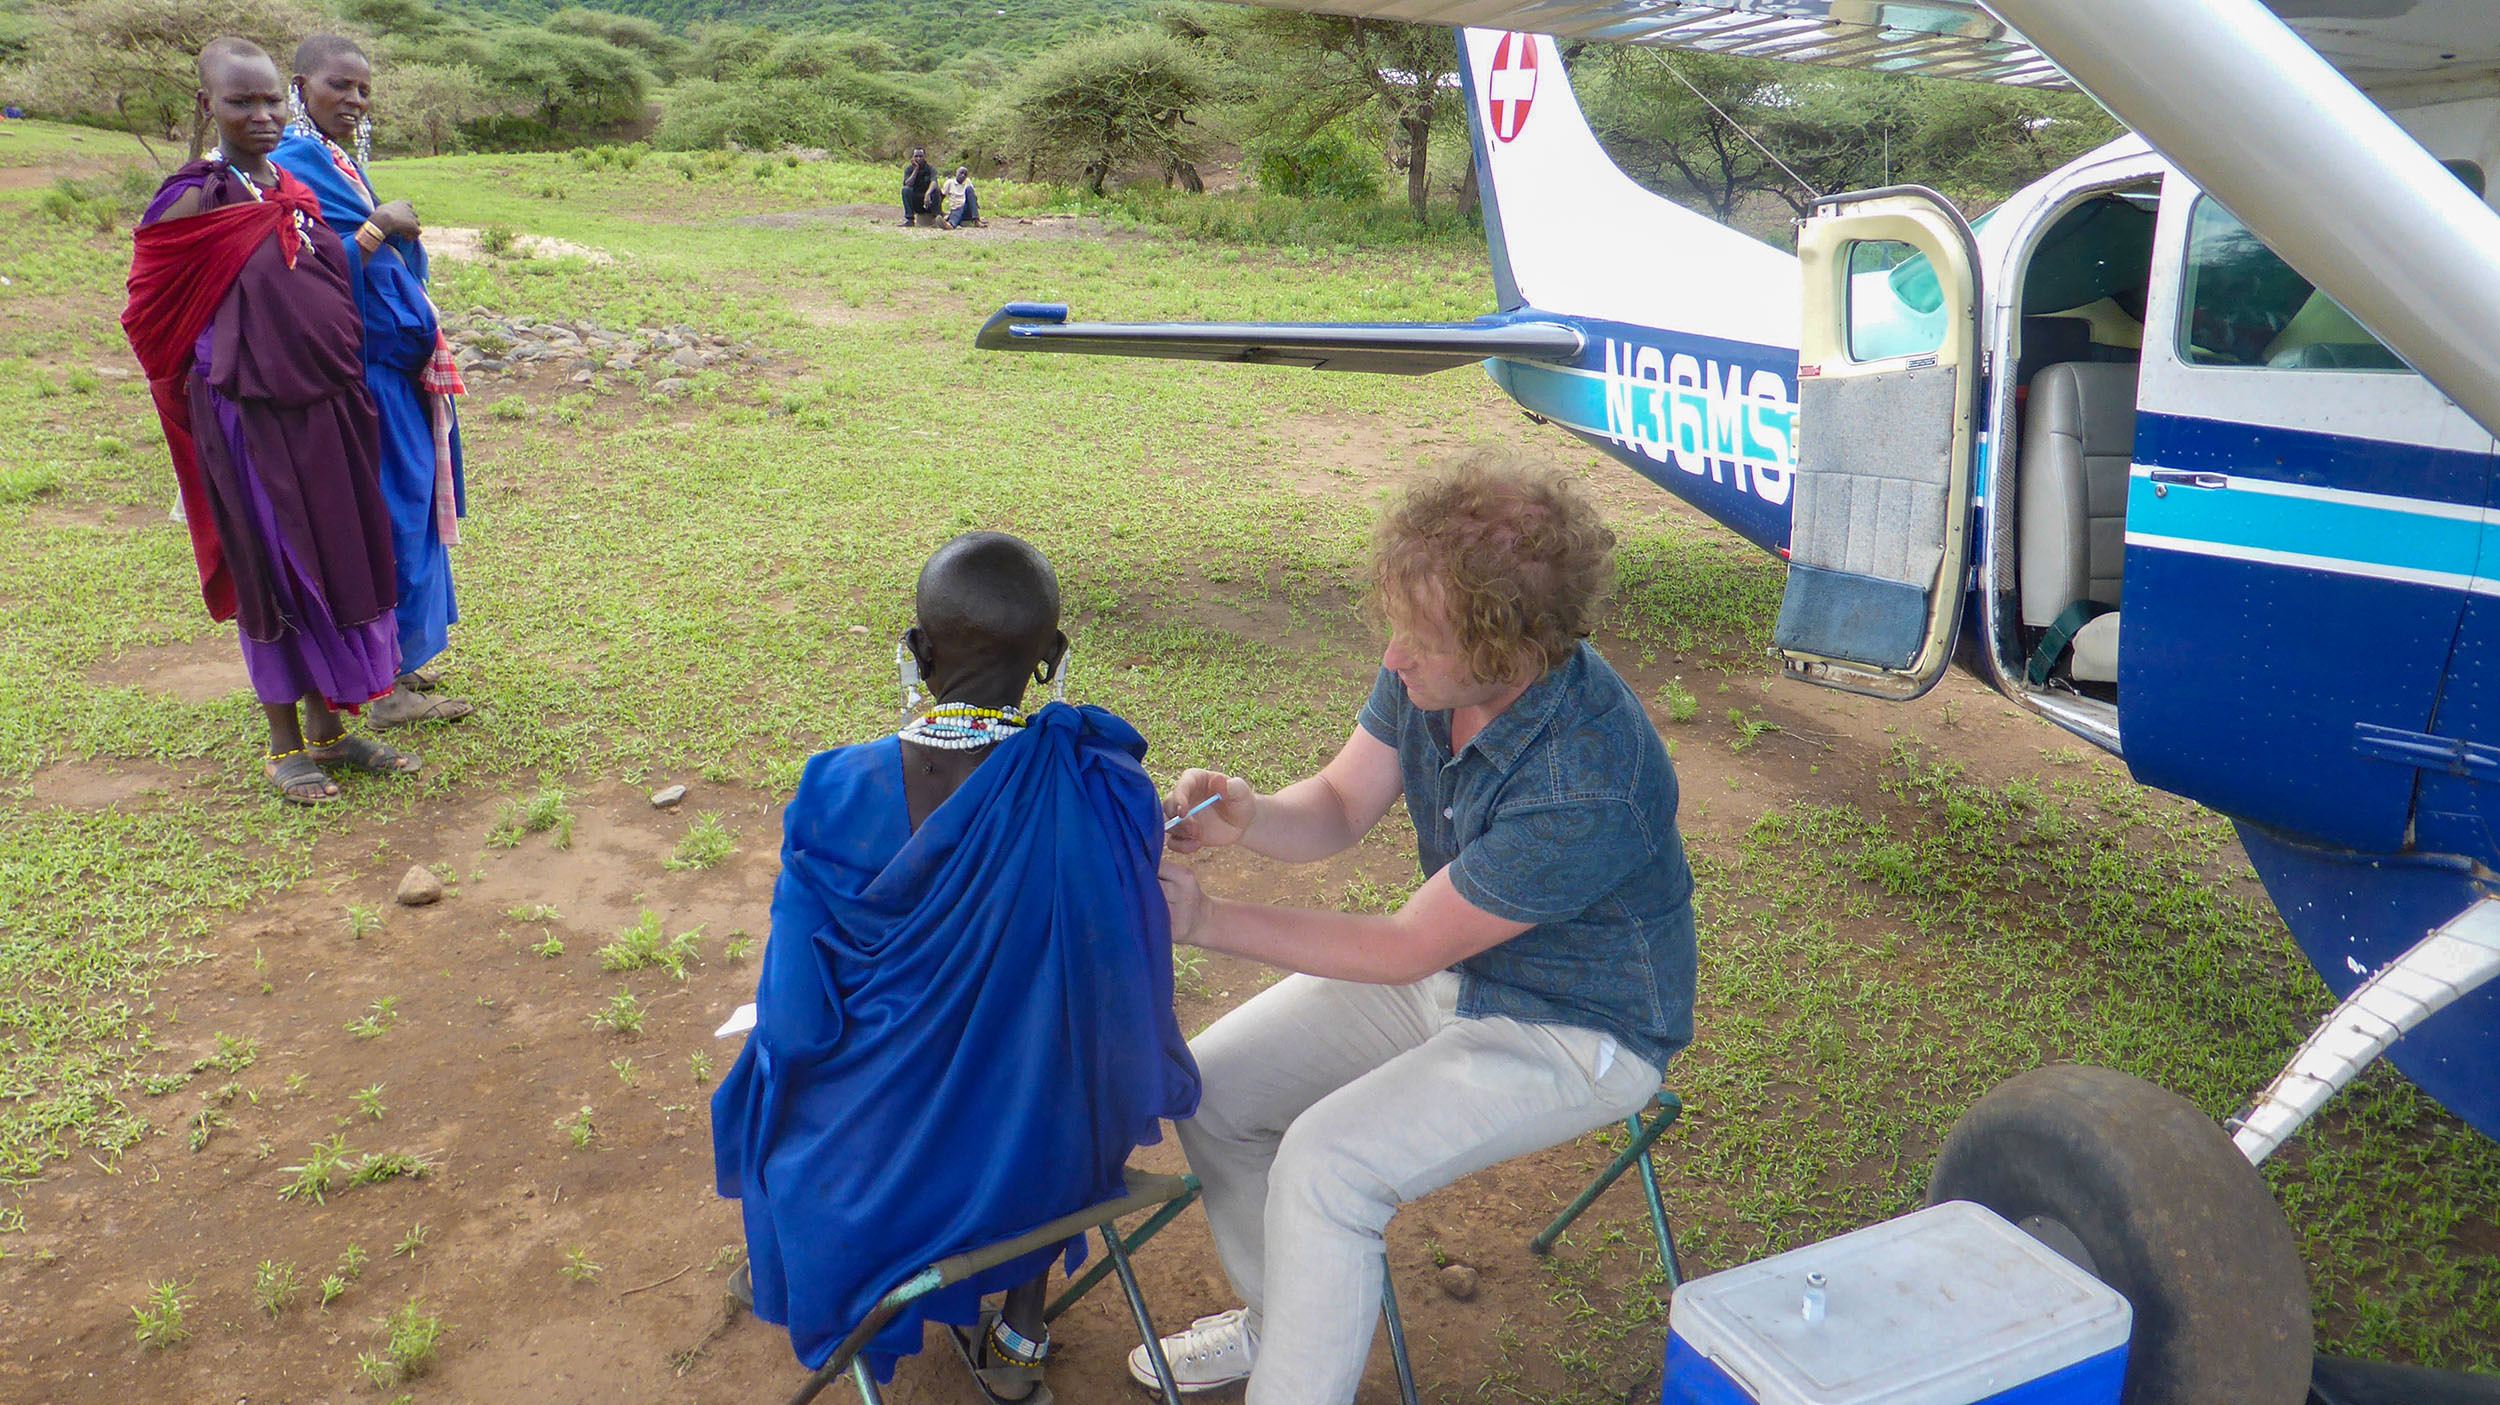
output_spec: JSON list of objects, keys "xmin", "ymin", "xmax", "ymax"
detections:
[{"xmin": 123, "ymin": 40, "xmax": 418, "ymax": 805}]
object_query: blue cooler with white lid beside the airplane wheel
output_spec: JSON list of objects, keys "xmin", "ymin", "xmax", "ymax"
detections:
[{"xmin": 1660, "ymin": 1200, "xmax": 2135, "ymax": 1405}]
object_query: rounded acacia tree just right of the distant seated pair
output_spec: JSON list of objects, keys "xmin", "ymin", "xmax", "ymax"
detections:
[{"xmin": 965, "ymin": 28, "xmax": 1218, "ymax": 195}]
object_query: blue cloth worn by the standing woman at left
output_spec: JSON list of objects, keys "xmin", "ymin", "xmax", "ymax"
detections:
[{"xmin": 270, "ymin": 130, "xmax": 468, "ymax": 670}]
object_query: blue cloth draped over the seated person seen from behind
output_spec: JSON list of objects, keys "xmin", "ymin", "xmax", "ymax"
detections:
[{"xmin": 713, "ymin": 705, "xmax": 1198, "ymax": 1380}]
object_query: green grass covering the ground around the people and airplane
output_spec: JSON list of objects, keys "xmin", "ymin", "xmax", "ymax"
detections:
[{"xmin": 0, "ymin": 136, "xmax": 2500, "ymax": 1398}]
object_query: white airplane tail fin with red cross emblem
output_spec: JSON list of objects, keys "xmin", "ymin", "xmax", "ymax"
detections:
[{"xmin": 1458, "ymin": 30, "xmax": 1798, "ymax": 348}]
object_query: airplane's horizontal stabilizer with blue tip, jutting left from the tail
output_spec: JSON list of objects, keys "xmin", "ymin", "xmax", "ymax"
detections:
[{"xmin": 973, "ymin": 303, "xmax": 1585, "ymax": 375}]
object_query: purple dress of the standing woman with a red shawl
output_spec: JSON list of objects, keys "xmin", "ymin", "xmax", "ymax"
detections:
[{"xmin": 140, "ymin": 160, "xmax": 400, "ymax": 710}]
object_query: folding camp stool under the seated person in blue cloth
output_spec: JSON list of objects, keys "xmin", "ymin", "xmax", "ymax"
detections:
[{"xmin": 790, "ymin": 1168, "xmax": 1205, "ymax": 1405}]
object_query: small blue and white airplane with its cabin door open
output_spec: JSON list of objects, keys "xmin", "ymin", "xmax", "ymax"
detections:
[{"xmin": 978, "ymin": 0, "xmax": 2500, "ymax": 1405}]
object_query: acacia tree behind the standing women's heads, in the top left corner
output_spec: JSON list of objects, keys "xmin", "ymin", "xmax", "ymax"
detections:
[{"xmin": 25, "ymin": 0, "xmax": 335, "ymax": 160}]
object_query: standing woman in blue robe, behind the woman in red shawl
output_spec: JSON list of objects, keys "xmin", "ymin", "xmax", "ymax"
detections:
[{"xmin": 270, "ymin": 35, "xmax": 475, "ymax": 730}]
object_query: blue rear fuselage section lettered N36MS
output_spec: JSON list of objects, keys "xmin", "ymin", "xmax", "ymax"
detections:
[{"xmin": 1485, "ymin": 310, "xmax": 1798, "ymax": 553}]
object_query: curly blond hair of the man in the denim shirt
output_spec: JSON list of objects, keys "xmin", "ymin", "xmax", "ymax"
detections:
[{"xmin": 1373, "ymin": 450, "xmax": 1615, "ymax": 683}]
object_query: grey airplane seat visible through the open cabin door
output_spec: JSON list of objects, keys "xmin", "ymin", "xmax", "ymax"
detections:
[{"xmin": 2015, "ymin": 363, "xmax": 2138, "ymax": 683}]
